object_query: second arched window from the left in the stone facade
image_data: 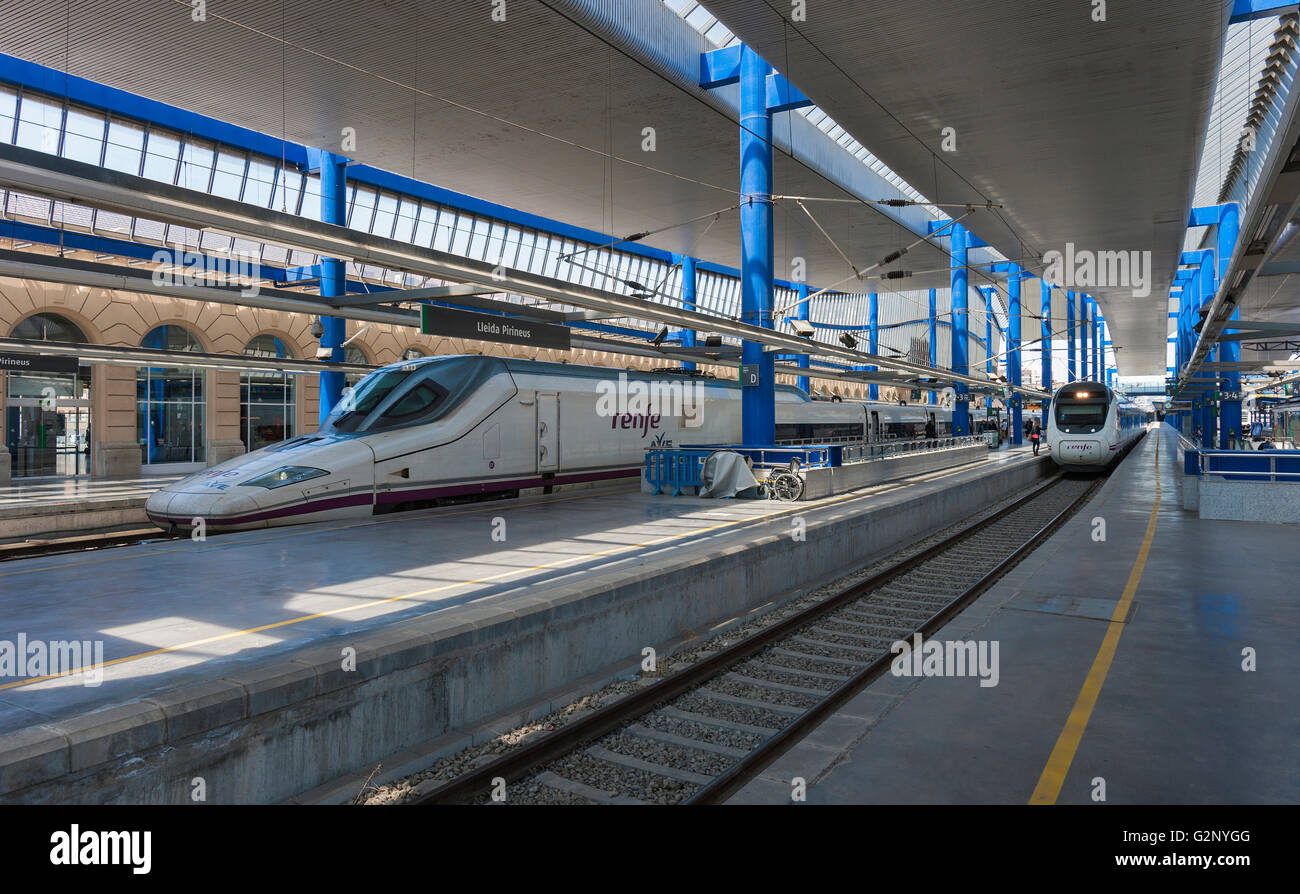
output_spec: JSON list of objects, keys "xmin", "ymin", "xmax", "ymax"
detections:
[{"xmin": 135, "ymin": 325, "xmax": 207, "ymax": 465}]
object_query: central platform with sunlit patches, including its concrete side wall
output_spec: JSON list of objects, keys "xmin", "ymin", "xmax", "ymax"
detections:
[{"xmin": 0, "ymin": 447, "xmax": 1050, "ymax": 802}]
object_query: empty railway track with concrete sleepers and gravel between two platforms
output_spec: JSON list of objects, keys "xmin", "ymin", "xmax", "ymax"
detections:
[{"xmin": 411, "ymin": 476, "xmax": 1104, "ymax": 804}]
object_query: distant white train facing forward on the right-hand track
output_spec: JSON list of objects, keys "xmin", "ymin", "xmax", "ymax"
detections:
[{"xmin": 1047, "ymin": 382, "xmax": 1148, "ymax": 472}]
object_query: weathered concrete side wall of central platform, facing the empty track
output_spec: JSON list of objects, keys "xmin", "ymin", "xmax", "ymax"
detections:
[{"xmin": 0, "ymin": 457, "xmax": 1054, "ymax": 803}]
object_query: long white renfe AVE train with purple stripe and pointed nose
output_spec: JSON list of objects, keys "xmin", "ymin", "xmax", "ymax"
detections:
[{"xmin": 146, "ymin": 356, "xmax": 952, "ymax": 531}]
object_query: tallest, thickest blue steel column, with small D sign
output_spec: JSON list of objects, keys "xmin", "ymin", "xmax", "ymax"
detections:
[{"xmin": 740, "ymin": 45, "xmax": 776, "ymax": 444}]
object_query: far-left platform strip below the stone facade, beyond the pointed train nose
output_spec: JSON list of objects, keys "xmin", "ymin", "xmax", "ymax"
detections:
[{"xmin": 0, "ymin": 476, "xmax": 182, "ymax": 541}]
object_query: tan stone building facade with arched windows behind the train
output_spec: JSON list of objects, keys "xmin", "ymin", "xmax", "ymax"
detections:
[{"xmin": 0, "ymin": 278, "xmax": 892, "ymax": 481}]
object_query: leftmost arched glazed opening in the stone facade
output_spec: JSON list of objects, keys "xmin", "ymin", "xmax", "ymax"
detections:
[{"xmin": 4, "ymin": 313, "xmax": 91, "ymax": 478}]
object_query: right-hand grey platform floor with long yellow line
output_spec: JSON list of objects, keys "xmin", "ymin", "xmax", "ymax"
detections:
[{"xmin": 731, "ymin": 425, "xmax": 1300, "ymax": 804}]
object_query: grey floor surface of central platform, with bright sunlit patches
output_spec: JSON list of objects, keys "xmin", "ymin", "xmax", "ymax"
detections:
[{"xmin": 0, "ymin": 448, "xmax": 1034, "ymax": 733}]
